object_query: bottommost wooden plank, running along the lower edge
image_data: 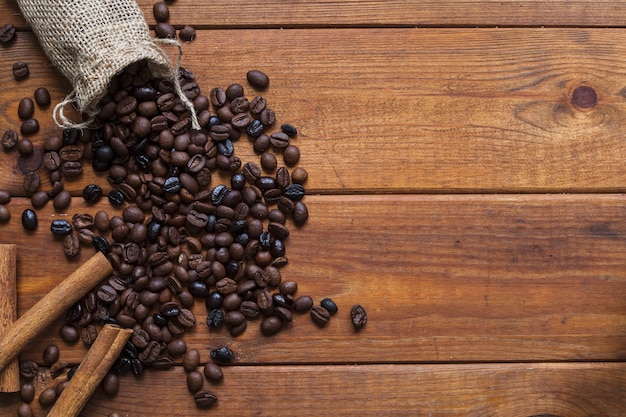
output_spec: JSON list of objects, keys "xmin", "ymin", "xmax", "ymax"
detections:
[{"xmin": 0, "ymin": 363, "xmax": 626, "ymax": 417}]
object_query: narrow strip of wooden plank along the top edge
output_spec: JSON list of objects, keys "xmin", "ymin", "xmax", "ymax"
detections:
[{"xmin": 8, "ymin": 0, "xmax": 626, "ymax": 29}]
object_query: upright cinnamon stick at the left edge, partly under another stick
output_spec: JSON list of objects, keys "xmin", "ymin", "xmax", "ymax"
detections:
[{"xmin": 0, "ymin": 244, "xmax": 20, "ymax": 392}]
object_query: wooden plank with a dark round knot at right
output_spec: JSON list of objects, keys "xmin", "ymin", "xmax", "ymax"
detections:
[{"xmin": 0, "ymin": 29, "xmax": 626, "ymax": 193}]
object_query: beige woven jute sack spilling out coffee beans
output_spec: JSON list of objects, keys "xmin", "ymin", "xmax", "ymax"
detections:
[{"xmin": 17, "ymin": 0, "xmax": 197, "ymax": 128}]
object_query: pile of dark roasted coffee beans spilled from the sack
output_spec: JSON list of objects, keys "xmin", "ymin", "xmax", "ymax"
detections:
[{"xmin": 0, "ymin": 2, "xmax": 367, "ymax": 416}]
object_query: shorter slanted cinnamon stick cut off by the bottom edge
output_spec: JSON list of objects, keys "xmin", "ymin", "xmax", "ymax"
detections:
[{"xmin": 48, "ymin": 324, "xmax": 133, "ymax": 417}]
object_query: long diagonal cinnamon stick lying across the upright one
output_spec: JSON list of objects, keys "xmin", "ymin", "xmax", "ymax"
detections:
[{"xmin": 0, "ymin": 252, "xmax": 113, "ymax": 370}]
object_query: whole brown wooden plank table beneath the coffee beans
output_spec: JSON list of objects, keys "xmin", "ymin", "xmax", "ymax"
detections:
[{"xmin": 0, "ymin": 0, "xmax": 626, "ymax": 417}]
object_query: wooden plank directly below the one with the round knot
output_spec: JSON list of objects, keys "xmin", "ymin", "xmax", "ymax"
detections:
[{"xmin": 0, "ymin": 195, "xmax": 626, "ymax": 363}]
